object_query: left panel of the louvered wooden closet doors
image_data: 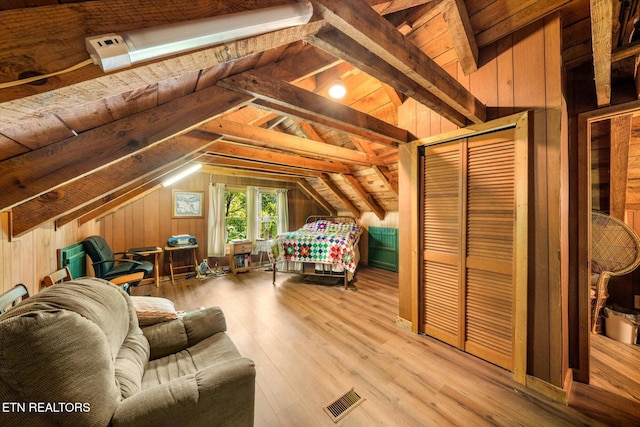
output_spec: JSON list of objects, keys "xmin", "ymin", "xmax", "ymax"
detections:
[{"xmin": 422, "ymin": 142, "xmax": 464, "ymax": 347}]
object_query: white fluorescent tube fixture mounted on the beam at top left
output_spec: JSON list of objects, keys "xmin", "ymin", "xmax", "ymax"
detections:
[{"xmin": 85, "ymin": 2, "xmax": 313, "ymax": 72}]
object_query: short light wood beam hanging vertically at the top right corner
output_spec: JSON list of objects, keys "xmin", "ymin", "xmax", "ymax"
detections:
[{"xmin": 590, "ymin": 0, "xmax": 613, "ymax": 107}]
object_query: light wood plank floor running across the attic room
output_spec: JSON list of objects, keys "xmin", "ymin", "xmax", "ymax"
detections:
[{"xmin": 132, "ymin": 266, "xmax": 640, "ymax": 427}]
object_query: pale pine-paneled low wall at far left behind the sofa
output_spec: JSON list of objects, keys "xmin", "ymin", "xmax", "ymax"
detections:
[{"xmin": 0, "ymin": 212, "xmax": 99, "ymax": 295}]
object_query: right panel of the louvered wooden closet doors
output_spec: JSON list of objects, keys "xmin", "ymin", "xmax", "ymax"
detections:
[{"xmin": 464, "ymin": 132, "xmax": 516, "ymax": 370}]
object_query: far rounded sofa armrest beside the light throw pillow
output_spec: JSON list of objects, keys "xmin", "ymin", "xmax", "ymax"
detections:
[{"xmin": 141, "ymin": 307, "xmax": 227, "ymax": 360}]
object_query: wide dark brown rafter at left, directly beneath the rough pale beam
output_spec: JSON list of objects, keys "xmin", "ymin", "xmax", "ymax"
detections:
[{"xmin": 0, "ymin": 86, "xmax": 251, "ymax": 210}]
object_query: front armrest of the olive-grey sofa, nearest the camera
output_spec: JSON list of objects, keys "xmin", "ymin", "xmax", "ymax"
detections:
[{"xmin": 111, "ymin": 357, "xmax": 256, "ymax": 427}]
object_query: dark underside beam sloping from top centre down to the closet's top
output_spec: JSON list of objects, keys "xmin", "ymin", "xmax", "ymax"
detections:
[{"xmin": 309, "ymin": 30, "xmax": 469, "ymax": 126}]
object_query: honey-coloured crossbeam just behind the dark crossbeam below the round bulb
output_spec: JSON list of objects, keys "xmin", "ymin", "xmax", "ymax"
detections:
[{"xmin": 200, "ymin": 119, "xmax": 386, "ymax": 166}]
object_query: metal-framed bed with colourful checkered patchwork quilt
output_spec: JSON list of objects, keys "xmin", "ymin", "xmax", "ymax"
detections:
[{"xmin": 268, "ymin": 215, "xmax": 362, "ymax": 289}]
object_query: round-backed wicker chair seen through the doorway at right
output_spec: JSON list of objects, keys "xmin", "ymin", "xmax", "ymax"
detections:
[{"xmin": 591, "ymin": 212, "xmax": 640, "ymax": 333}]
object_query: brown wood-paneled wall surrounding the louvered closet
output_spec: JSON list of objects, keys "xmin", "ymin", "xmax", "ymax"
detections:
[{"xmin": 398, "ymin": 15, "xmax": 568, "ymax": 387}]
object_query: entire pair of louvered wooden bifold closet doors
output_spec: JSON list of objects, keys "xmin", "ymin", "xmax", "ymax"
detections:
[{"xmin": 422, "ymin": 130, "xmax": 526, "ymax": 370}]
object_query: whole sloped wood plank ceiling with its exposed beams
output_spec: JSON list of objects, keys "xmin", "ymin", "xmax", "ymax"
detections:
[{"xmin": 0, "ymin": 0, "xmax": 640, "ymax": 236}]
